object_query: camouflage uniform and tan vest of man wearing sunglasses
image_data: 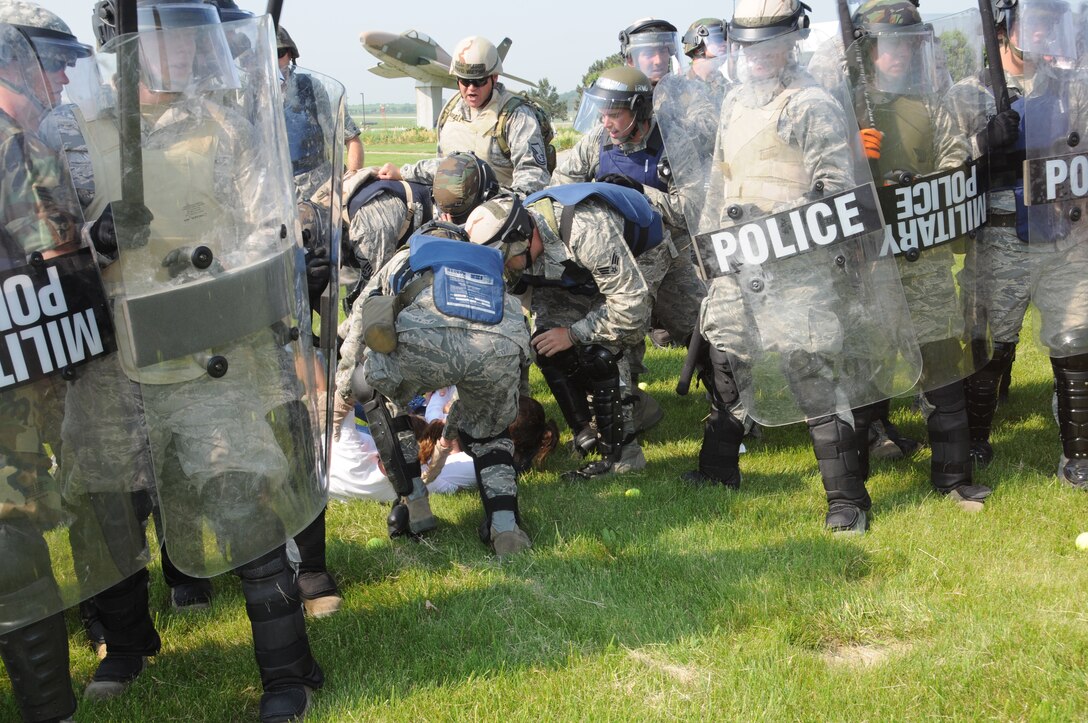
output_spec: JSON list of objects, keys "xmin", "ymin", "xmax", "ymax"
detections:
[{"xmin": 400, "ymin": 83, "xmax": 549, "ymax": 195}]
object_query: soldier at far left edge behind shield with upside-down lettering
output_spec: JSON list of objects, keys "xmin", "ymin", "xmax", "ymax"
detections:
[{"xmin": 0, "ymin": 2, "xmax": 159, "ymax": 721}]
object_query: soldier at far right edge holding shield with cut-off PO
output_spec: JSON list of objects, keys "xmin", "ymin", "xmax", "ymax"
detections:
[{"xmin": 945, "ymin": 0, "xmax": 1088, "ymax": 489}]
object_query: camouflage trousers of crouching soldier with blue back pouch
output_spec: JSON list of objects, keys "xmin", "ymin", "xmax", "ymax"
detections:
[{"xmin": 363, "ymin": 327, "xmax": 524, "ymax": 499}]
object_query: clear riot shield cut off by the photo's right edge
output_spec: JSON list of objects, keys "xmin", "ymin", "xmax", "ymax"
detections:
[{"xmin": 1009, "ymin": 0, "xmax": 1088, "ymax": 357}]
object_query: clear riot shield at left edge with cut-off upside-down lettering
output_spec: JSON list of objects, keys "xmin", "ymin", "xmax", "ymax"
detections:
[{"xmin": 0, "ymin": 25, "xmax": 150, "ymax": 633}]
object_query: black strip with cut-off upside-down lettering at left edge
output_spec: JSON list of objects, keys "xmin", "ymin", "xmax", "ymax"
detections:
[{"xmin": 0, "ymin": 249, "xmax": 116, "ymax": 389}]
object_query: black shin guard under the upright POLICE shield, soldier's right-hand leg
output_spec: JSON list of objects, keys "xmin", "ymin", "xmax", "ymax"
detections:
[{"xmin": 808, "ymin": 416, "xmax": 873, "ymax": 529}]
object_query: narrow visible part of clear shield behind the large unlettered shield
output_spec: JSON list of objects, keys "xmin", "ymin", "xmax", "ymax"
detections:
[{"xmin": 284, "ymin": 67, "xmax": 344, "ymax": 471}]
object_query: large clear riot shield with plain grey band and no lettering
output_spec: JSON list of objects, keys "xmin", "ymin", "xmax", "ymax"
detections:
[{"xmin": 75, "ymin": 16, "xmax": 325, "ymax": 576}]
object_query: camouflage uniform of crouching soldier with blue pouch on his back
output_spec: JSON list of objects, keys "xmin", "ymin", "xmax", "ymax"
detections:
[{"xmin": 336, "ymin": 249, "xmax": 529, "ymax": 510}]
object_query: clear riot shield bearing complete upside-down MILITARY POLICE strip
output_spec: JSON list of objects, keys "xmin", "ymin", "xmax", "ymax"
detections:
[{"xmin": 845, "ymin": 10, "xmax": 991, "ymax": 391}]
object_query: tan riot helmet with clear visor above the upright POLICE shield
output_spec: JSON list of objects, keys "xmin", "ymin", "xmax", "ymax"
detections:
[{"xmin": 728, "ymin": 0, "xmax": 811, "ymax": 83}]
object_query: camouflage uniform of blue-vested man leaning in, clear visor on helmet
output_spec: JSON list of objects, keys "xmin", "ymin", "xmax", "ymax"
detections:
[{"xmin": 551, "ymin": 121, "xmax": 706, "ymax": 357}]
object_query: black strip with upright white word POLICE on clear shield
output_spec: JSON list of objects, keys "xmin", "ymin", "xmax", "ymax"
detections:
[{"xmin": 695, "ymin": 184, "xmax": 883, "ymax": 278}]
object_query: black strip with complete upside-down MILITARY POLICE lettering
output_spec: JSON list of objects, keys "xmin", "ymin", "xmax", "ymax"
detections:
[{"xmin": 877, "ymin": 162, "xmax": 987, "ymax": 257}]
